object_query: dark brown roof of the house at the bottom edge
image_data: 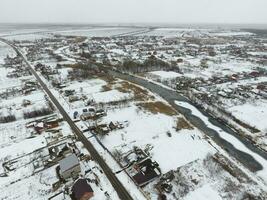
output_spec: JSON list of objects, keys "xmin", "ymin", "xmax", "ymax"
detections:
[{"xmin": 72, "ymin": 179, "xmax": 94, "ymax": 199}]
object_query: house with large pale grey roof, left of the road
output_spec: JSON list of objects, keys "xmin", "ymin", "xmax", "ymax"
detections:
[{"xmin": 59, "ymin": 154, "xmax": 81, "ymax": 179}]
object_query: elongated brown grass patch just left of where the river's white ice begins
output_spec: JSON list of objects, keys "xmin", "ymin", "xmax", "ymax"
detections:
[{"xmin": 137, "ymin": 101, "xmax": 177, "ymax": 116}]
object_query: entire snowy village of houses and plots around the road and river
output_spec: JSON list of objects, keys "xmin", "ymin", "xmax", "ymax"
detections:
[{"xmin": 0, "ymin": 25, "xmax": 267, "ymax": 200}]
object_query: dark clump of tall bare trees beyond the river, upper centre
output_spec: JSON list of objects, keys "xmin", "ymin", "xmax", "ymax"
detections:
[{"xmin": 117, "ymin": 55, "xmax": 180, "ymax": 73}]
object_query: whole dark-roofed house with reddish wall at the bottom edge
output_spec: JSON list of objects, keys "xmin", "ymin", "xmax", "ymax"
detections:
[{"xmin": 71, "ymin": 179, "xmax": 94, "ymax": 200}]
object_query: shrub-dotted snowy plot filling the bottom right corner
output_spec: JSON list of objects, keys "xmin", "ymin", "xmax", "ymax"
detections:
[{"xmin": 156, "ymin": 154, "xmax": 267, "ymax": 200}]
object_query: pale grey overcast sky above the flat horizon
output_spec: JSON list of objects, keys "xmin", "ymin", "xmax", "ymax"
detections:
[{"xmin": 0, "ymin": 0, "xmax": 267, "ymax": 24}]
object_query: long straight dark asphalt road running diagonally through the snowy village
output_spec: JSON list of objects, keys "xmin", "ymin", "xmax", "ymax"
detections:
[{"xmin": 0, "ymin": 39, "xmax": 133, "ymax": 200}]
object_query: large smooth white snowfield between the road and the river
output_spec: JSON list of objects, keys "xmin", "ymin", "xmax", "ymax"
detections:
[{"xmin": 97, "ymin": 105, "xmax": 215, "ymax": 173}]
